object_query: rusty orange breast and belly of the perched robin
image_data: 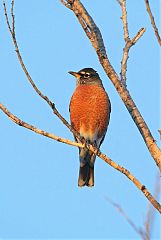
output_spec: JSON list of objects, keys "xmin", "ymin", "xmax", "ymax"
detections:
[{"xmin": 70, "ymin": 85, "xmax": 110, "ymax": 139}]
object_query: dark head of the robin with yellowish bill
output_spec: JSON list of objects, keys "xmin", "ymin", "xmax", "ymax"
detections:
[{"xmin": 69, "ymin": 68, "xmax": 102, "ymax": 85}]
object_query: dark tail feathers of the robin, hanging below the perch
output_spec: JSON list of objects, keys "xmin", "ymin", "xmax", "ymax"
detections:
[{"xmin": 78, "ymin": 162, "xmax": 94, "ymax": 187}]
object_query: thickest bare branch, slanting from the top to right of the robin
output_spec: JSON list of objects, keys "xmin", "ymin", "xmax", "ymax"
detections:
[{"xmin": 60, "ymin": 0, "xmax": 161, "ymax": 171}]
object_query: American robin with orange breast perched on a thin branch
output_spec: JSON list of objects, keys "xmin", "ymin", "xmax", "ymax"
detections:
[{"xmin": 69, "ymin": 68, "xmax": 111, "ymax": 187}]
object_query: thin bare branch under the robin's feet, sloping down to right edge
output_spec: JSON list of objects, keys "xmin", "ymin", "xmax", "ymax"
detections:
[{"xmin": 0, "ymin": 103, "xmax": 161, "ymax": 213}]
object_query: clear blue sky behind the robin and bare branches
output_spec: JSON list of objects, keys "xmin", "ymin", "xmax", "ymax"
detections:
[{"xmin": 0, "ymin": 0, "xmax": 161, "ymax": 239}]
